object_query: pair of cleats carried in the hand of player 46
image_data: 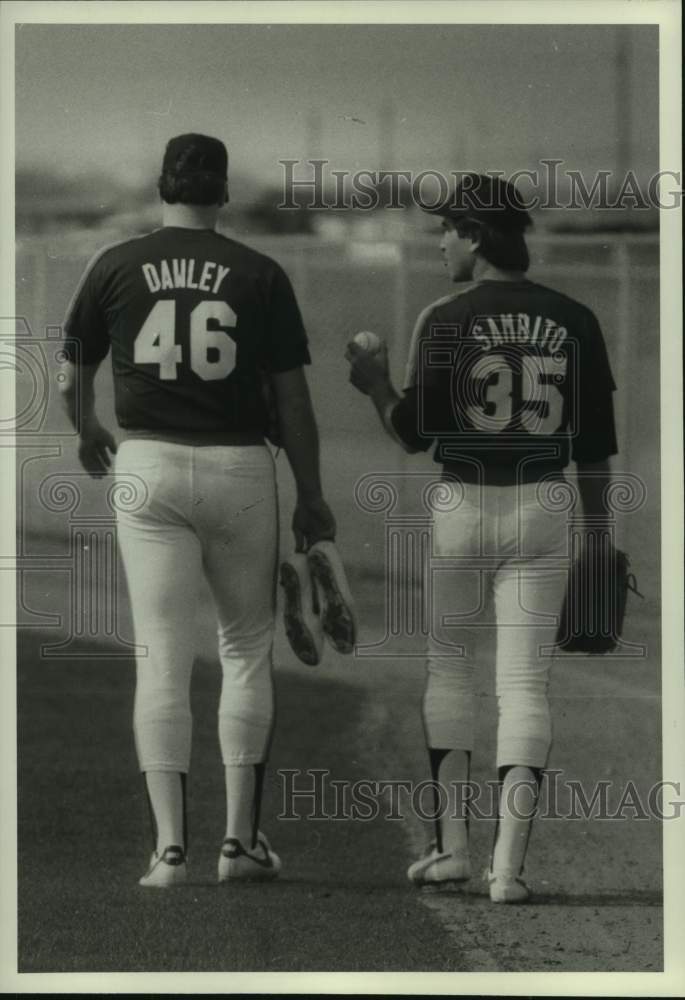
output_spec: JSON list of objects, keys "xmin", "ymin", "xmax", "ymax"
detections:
[{"xmin": 280, "ymin": 541, "xmax": 357, "ymax": 667}]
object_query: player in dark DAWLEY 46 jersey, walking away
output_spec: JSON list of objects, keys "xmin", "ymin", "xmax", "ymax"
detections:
[{"xmin": 62, "ymin": 134, "xmax": 335, "ymax": 888}]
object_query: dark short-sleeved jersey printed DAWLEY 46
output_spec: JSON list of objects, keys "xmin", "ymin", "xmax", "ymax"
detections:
[{"xmin": 64, "ymin": 226, "xmax": 310, "ymax": 433}]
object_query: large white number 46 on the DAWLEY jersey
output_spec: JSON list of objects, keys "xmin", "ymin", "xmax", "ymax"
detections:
[{"xmin": 133, "ymin": 299, "xmax": 238, "ymax": 382}]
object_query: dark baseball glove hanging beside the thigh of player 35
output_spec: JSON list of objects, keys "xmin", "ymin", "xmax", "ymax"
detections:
[{"xmin": 557, "ymin": 535, "xmax": 642, "ymax": 655}]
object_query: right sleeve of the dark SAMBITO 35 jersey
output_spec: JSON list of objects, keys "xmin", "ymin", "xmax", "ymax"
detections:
[{"xmin": 571, "ymin": 313, "xmax": 618, "ymax": 462}]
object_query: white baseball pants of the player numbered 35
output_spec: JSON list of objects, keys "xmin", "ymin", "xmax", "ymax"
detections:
[{"xmin": 423, "ymin": 483, "xmax": 568, "ymax": 768}]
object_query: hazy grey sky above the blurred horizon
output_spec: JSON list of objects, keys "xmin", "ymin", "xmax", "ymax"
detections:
[{"xmin": 16, "ymin": 24, "xmax": 658, "ymax": 194}]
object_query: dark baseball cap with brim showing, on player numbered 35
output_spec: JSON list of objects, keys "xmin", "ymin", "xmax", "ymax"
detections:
[{"xmin": 421, "ymin": 174, "xmax": 533, "ymax": 232}]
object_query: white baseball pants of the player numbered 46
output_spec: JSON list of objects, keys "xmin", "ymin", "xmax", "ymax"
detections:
[{"xmin": 116, "ymin": 439, "xmax": 278, "ymax": 773}]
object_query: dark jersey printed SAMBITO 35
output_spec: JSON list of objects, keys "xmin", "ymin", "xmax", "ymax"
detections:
[{"xmin": 392, "ymin": 281, "xmax": 616, "ymax": 482}]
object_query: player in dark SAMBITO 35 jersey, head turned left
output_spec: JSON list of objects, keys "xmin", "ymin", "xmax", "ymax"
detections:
[{"xmin": 347, "ymin": 175, "xmax": 616, "ymax": 903}]
